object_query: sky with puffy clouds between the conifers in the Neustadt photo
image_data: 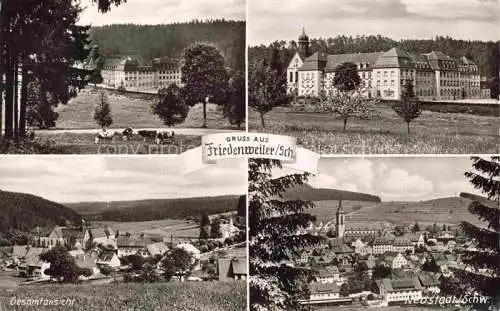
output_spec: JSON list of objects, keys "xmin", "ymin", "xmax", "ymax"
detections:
[{"xmin": 309, "ymin": 156, "xmax": 486, "ymax": 201}]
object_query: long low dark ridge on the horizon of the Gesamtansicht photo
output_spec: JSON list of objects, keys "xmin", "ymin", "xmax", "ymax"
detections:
[{"xmin": 66, "ymin": 195, "xmax": 244, "ymax": 221}]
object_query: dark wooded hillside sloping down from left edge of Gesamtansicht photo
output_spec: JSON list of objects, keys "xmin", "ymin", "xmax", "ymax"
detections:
[{"xmin": 0, "ymin": 190, "xmax": 82, "ymax": 233}]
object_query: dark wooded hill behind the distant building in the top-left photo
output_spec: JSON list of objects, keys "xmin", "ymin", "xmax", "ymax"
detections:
[{"xmin": 89, "ymin": 19, "xmax": 245, "ymax": 71}]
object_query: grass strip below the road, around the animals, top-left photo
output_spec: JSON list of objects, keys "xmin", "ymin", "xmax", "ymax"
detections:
[{"xmin": 26, "ymin": 133, "xmax": 201, "ymax": 155}]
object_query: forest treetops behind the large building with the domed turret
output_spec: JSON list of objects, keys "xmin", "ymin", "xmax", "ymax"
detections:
[{"xmin": 248, "ymin": 35, "xmax": 500, "ymax": 78}]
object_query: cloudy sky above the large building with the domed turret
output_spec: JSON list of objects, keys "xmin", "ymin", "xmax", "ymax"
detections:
[{"xmin": 248, "ymin": 0, "xmax": 500, "ymax": 45}]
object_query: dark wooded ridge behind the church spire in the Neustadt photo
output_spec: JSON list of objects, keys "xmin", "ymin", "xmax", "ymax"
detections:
[{"xmin": 283, "ymin": 185, "xmax": 381, "ymax": 203}]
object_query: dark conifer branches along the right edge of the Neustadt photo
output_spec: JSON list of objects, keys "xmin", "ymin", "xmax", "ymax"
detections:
[{"xmin": 441, "ymin": 156, "xmax": 500, "ymax": 310}]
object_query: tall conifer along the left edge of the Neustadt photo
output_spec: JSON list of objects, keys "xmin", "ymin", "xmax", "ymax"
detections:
[{"xmin": 248, "ymin": 159, "xmax": 323, "ymax": 311}]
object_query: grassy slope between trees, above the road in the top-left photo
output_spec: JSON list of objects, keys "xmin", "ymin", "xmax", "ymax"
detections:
[{"xmin": 56, "ymin": 87, "xmax": 238, "ymax": 129}]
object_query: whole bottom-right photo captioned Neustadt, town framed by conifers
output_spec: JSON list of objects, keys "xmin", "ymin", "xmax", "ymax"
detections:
[{"xmin": 248, "ymin": 156, "xmax": 500, "ymax": 311}]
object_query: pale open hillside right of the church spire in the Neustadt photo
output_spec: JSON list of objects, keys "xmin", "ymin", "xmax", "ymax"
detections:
[{"xmin": 346, "ymin": 197, "xmax": 480, "ymax": 224}]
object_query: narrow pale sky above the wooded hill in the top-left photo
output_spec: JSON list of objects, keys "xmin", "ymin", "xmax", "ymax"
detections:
[{"xmin": 79, "ymin": 0, "xmax": 246, "ymax": 26}]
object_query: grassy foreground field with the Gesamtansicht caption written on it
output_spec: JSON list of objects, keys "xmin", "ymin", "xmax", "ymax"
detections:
[{"xmin": 0, "ymin": 282, "xmax": 246, "ymax": 311}]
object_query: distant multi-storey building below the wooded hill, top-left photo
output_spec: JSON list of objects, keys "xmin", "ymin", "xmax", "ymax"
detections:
[{"xmin": 101, "ymin": 56, "xmax": 181, "ymax": 92}]
